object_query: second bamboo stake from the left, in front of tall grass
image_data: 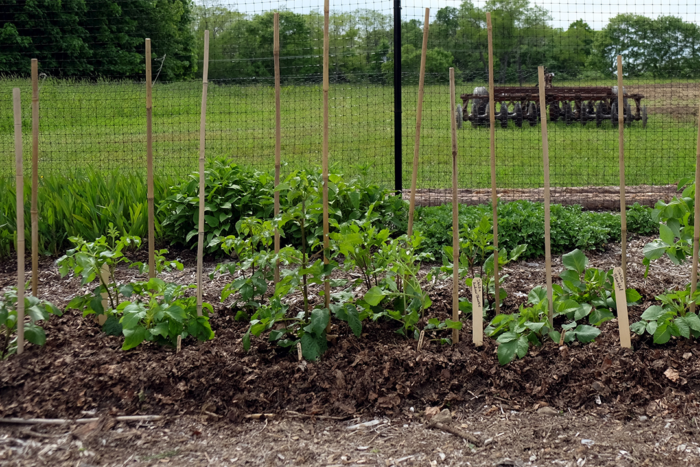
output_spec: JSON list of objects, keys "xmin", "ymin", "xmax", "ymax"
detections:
[{"xmin": 31, "ymin": 58, "xmax": 39, "ymax": 297}]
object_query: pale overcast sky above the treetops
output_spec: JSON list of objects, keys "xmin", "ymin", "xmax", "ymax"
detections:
[{"xmin": 212, "ymin": 0, "xmax": 700, "ymax": 29}]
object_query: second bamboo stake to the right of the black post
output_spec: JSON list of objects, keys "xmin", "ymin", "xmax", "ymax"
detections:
[{"xmin": 452, "ymin": 68, "xmax": 459, "ymax": 344}]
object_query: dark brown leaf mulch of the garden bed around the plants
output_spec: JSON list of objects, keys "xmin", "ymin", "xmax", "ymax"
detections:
[{"xmin": 0, "ymin": 238, "xmax": 700, "ymax": 421}]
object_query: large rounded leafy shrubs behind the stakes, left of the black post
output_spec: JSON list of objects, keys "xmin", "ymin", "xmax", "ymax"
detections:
[{"xmin": 159, "ymin": 159, "xmax": 406, "ymax": 252}]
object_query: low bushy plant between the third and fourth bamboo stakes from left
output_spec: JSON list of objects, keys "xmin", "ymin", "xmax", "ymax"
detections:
[{"xmin": 116, "ymin": 278, "xmax": 214, "ymax": 350}]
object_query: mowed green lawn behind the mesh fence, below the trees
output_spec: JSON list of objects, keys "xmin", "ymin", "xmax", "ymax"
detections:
[{"xmin": 0, "ymin": 79, "xmax": 697, "ymax": 188}]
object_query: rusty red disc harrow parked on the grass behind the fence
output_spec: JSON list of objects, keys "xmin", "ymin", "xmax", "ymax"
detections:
[{"xmin": 455, "ymin": 74, "xmax": 647, "ymax": 128}]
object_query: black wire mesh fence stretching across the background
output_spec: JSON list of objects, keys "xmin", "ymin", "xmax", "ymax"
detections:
[{"xmin": 0, "ymin": 0, "xmax": 700, "ymax": 209}]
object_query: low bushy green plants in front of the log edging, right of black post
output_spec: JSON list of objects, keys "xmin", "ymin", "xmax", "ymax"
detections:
[{"xmin": 415, "ymin": 200, "xmax": 657, "ymax": 259}]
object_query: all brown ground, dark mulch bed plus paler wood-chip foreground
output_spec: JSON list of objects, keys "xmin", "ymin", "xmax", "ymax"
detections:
[{"xmin": 0, "ymin": 238, "xmax": 700, "ymax": 466}]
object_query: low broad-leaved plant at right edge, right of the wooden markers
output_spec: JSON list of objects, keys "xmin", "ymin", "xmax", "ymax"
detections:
[{"xmin": 630, "ymin": 284, "xmax": 700, "ymax": 344}]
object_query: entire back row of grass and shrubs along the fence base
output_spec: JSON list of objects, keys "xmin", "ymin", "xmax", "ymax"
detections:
[{"xmin": 0, "ymin": 159, "xmax": 658, "ymax": 258}]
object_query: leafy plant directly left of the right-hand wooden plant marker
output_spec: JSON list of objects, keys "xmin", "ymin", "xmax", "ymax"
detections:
[{"xmin": 552, "ymin": 250, "xmax": 642, "ymax": 326}]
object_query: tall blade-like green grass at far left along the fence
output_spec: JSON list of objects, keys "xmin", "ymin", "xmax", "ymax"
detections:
[{"xmin": 0, "ymin": 169, "xmax": 175, "ymax": 256}]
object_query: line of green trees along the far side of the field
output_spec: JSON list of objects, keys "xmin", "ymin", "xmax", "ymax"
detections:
[{"xmin": 0, "ymin": 0, "xmax": 700, "ymax": 84}]
